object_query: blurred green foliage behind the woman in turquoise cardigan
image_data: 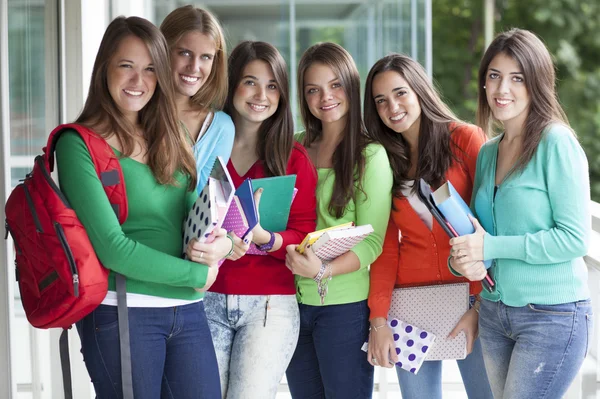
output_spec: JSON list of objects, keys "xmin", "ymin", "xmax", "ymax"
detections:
[{"xmin": 433, "ymin": 0, "xmax": 600, "ymax": 201}]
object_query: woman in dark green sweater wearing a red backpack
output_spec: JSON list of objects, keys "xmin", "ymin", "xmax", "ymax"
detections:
[{"xmin": 56, "ymin": 17, "xmax": 231, "ymax": 399}]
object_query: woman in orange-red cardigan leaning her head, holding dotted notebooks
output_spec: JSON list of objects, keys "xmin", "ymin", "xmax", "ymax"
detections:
[{"xmin": 364, "ymin": 54, "xmax": 492, "ymax": 399}]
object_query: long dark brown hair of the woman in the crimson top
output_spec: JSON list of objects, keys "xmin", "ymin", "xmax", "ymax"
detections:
[{"xmin": 225, "ymin": 41, "xmax": 294, "ymax": 176}]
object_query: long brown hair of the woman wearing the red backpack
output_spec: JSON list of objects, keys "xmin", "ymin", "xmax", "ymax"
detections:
[{"xmin": 76, "ymin": 17, "xmax": 196, "ymax": 190}]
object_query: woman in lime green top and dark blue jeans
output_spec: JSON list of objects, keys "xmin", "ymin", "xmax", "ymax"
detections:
[{"xmin": 286, "ymin": 43, "xmax": 392, "ymax": 399}]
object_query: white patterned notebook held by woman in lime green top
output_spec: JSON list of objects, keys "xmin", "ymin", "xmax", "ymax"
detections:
[{"xmin": 312, "ymin": 224, "xmax": 373, "ymax": 262}]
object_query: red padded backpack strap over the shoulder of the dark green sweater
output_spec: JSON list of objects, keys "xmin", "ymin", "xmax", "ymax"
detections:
[{"xmin": 44, "ymin": 123, "xmax": 128, "ymax": 224}]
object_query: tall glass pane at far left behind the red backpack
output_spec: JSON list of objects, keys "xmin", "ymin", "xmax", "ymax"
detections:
[{"xmin": 7, "ymin": 0, "xmax": 59, "ymax": 399}]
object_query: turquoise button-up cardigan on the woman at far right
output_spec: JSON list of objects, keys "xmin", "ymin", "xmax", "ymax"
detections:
[{"xmin": 471, "ymin": 124, "xmax": 591, "ymax": 306}]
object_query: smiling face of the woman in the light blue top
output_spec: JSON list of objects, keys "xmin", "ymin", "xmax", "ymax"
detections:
[{"xmin": 171, "ymin": 31, "xmax": 217, "ymax": 101}]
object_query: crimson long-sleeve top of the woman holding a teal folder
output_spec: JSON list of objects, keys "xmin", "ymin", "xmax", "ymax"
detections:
[{"xmin": 210, "ymin": 143, "xmax": 317, "ymax": 295}]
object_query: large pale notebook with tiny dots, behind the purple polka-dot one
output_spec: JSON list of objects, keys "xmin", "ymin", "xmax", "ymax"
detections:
[{"xmin": 388, "ymin": 283, "xmax": 469, "ymax": 360}]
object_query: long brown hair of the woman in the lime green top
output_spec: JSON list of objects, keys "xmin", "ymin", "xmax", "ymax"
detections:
[{"xmin": 298, "ymin": 42, "xmax": 369, "ymax": 218}]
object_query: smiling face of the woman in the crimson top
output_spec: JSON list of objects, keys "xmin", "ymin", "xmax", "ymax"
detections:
[{"xmin": 233, "ymin": 60, "xmax": 280, "ymax": 123}]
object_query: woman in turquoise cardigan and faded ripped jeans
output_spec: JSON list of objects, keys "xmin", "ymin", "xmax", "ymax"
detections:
[{"xmin": 450, "ymin": 29, "xmax": 592, "ymax": 398}]
